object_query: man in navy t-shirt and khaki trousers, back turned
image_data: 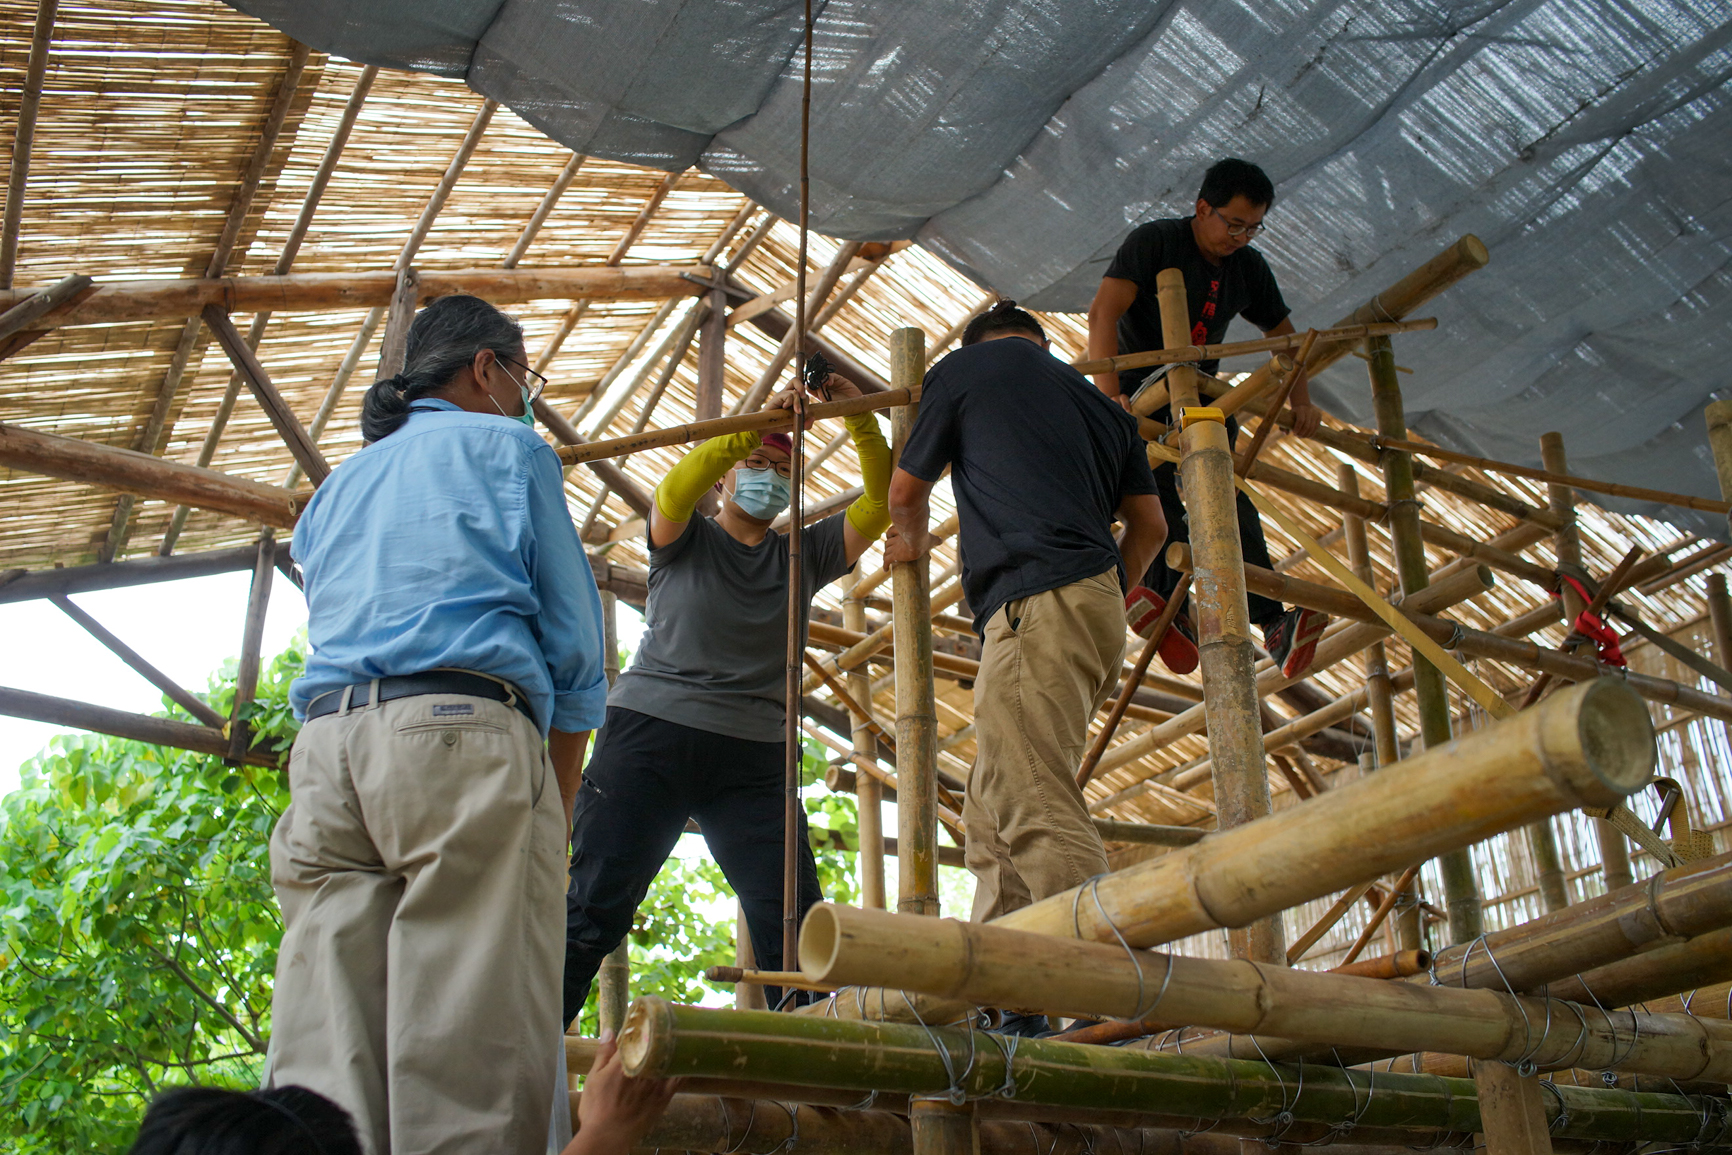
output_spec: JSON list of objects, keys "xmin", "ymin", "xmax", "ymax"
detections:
[{"xmin": 885, "ymin": 301, "xmax": 1166, "ymax": 921}]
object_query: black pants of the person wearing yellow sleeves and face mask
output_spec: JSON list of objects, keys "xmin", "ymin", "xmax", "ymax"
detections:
[{"xmin": 565, "ymin": 707, "xmax": 823, "ymax": 1025}]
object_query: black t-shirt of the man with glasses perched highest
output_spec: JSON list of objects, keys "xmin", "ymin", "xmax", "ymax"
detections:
[{"xmin": 1107, "ymin": 216, "xmax": 1292, "ymax": 395}]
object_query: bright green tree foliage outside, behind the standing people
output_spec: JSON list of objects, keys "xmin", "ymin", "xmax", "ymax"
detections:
[{"xmin": 0, "ymin": 646, "xmax": 857, "ymax": 1155}]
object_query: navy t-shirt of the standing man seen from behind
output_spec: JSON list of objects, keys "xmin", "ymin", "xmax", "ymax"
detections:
[{"xmin": 899, "ymin": 338, "xmax": 1155, "ymax": 632}]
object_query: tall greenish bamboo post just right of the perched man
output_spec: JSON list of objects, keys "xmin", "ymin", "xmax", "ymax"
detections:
[{"xmin": 1365, "ymin": 338, "xmax": 1481, "ymax": 942}]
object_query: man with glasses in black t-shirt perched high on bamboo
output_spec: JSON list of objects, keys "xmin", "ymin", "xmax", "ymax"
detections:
[{"xmin": 1088, "ymin": 158, "xmax": 1328, "ymax": 677}]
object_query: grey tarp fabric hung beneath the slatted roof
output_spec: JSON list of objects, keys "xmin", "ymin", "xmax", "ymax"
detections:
[{"xmin": 223, "ymin": 0, "xmax": 1732, "ymax": 537}]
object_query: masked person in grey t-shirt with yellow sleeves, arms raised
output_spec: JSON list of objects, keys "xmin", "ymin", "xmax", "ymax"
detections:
[{"xmin": 565, "ymin": 376, "xmax": 890, "ymax": 1023}]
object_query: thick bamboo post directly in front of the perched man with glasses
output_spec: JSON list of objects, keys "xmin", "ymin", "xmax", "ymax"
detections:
[{"xmin": 1155, "ymin": 268, "xmax": 1287, "ymax": 965}]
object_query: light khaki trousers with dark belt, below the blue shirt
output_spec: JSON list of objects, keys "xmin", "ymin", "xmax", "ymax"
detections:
[{"xmin": 265, "ymin": 694, "xmax": 565, "ymax": 1155}]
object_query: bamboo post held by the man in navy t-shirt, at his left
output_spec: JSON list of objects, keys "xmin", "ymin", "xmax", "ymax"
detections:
[{"xmin": 890, "ymin": 327, "xmax": 939, "ymax": 916}]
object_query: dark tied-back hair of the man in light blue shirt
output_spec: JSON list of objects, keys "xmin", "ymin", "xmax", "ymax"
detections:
[{"xmin": 360, "ymin": 296, "xmax": 523, "ymax": 442}]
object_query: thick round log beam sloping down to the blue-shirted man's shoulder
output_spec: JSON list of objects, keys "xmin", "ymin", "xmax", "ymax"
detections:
[{"xmin": 0, "ymin": 423, "xmax": 305, "ymax": 530}]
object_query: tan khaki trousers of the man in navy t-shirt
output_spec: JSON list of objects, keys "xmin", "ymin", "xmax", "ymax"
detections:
[{"xmin": 963, "ymin": 571, "xmax": 1124, "ymax": 923}]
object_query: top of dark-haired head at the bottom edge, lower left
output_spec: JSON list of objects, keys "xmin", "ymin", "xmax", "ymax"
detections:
[{"xmin": 128, "ymin": 1087, "xmax": 360, "ymax": 1155}]
